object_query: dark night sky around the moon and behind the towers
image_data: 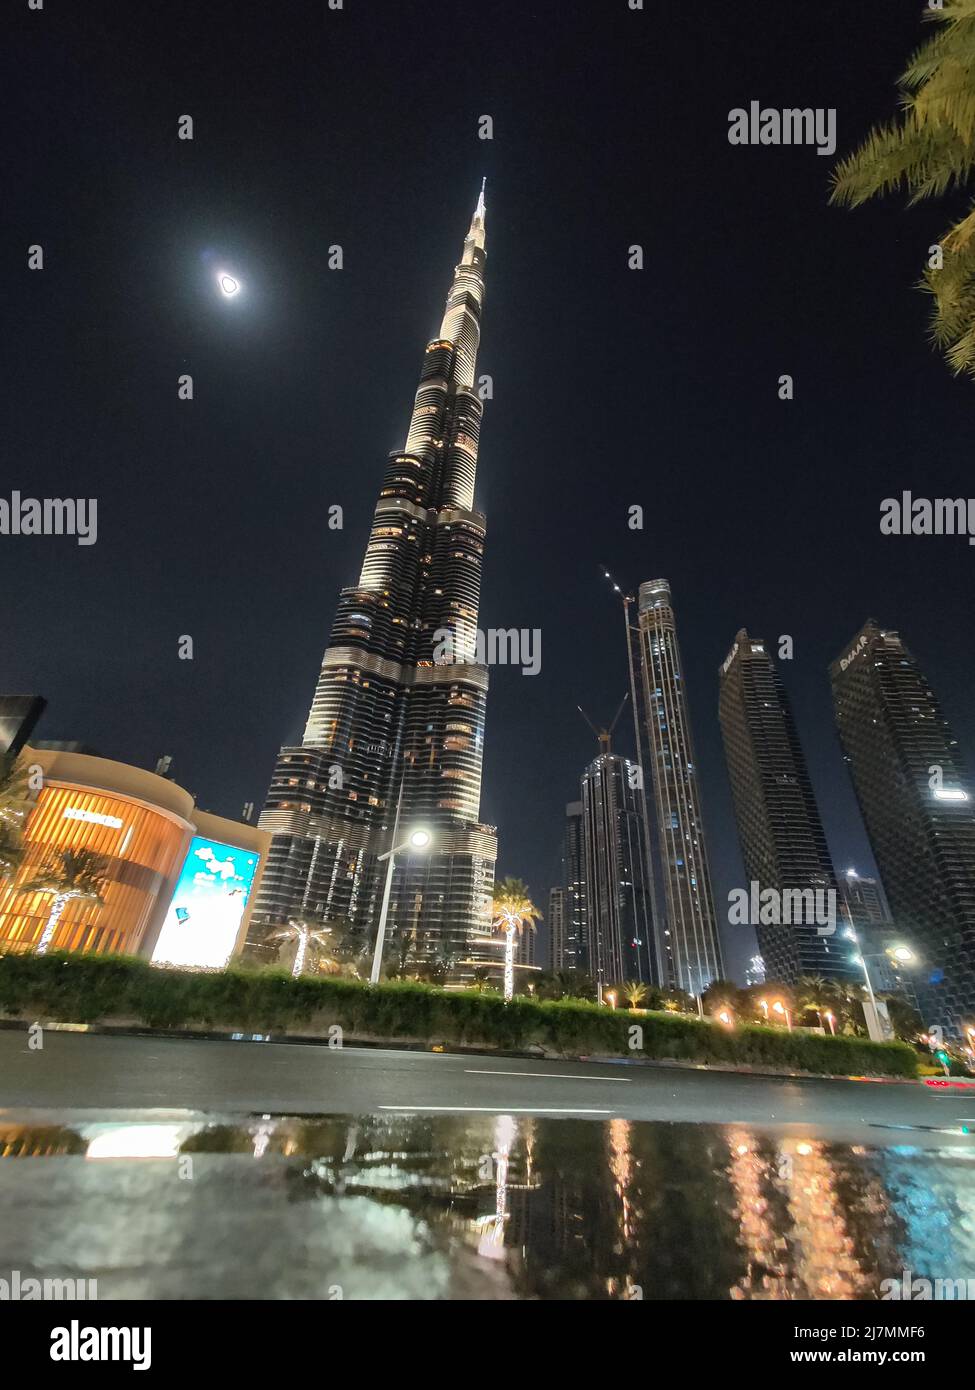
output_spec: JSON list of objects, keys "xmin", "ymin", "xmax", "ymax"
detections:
[{"xmin": 0, "ymin": 0, "xmax": 975, "ymax": 970}]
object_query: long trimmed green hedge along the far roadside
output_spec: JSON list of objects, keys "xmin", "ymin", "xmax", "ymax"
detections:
[{"xmin": 0, "ymin": 952, "xmax": 917, "ymax": 1077}]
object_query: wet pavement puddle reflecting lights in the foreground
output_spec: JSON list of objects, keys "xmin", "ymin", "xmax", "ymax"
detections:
[{"xmin": 0, "ymin": 1112, "xmax": 975, "ymax": 1300}]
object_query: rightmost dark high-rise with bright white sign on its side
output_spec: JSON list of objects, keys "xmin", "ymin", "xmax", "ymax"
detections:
[{"xmin": 829, "ymin": 620, "xmax": 975, "ymax": 1029}]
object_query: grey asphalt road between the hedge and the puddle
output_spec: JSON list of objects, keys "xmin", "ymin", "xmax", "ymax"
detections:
[{"xmin": 0, "ymin": 1030, "xmax": 975, "ymax": 1144}]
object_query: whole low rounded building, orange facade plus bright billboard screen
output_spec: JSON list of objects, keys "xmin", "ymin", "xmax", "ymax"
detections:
[{"xmin": 0, "ymin": 745, "xmax": 271, "ymax": 969}]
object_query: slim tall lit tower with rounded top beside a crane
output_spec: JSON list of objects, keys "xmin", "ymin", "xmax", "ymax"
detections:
[{"xmin": 637, "ymin": 580, "xmax": 723, "ymax": 994}]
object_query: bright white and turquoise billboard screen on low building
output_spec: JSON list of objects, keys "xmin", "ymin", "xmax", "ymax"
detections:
[{"xmin": 153, "ymin": 835, "xmax": 260, "ymax": 970}]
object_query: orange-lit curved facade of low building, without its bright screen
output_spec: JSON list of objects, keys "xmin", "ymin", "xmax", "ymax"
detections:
[{"xmin": 0, "ymin": 748, "xmax": 270, "ymax": 955}]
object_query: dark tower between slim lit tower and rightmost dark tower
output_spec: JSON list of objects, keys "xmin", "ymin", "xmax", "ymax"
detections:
[{"xmin": 719, "ymin": 628, "xmax": 855, "ymax": 984}]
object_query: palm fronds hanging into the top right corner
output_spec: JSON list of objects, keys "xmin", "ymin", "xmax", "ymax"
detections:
[{"xmin": 830, "ymin": 0, "xmax": 975, "ymax": 377}]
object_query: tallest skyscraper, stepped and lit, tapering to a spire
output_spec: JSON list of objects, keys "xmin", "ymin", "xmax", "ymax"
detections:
[{"xmin": 255, "ymin": 189, "xmax": 497, "ymax": 974}]
